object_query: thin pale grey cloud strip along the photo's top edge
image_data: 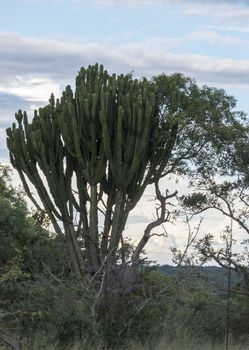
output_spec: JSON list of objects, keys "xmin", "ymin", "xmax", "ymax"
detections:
[{"xmin": 14, "ymin": 0, "xmax": 249, "ymax": 34}]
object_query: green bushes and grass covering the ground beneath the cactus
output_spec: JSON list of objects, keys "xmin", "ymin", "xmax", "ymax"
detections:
[{"xmin": 0, "ymin": 168, "xmax": 249, "ymax": 350}]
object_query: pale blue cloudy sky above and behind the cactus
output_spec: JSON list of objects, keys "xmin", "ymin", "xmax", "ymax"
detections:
[{"xmin": 0, "ymin": 0, "xmax": 249, "ymax": 263}]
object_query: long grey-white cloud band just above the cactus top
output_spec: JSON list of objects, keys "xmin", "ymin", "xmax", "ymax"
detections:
[{"xmin": 0, "ymin": 33, "xmax": 249, "ymax": 89}]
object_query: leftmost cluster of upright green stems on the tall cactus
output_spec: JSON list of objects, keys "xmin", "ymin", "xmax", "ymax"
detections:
[{"xmin": 7, "ymin": 100, "xmax": 84, "ymax": 276}]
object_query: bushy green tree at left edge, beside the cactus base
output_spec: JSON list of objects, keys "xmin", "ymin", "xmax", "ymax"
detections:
[{"xmin": 0, "ymin": 166, "xmax": 70, "ymax": 340}]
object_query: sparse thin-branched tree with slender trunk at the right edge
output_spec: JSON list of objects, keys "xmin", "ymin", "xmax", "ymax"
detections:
[{"xmin": 178, "ymin": 172, "xmax": 249, "ymax": 349}]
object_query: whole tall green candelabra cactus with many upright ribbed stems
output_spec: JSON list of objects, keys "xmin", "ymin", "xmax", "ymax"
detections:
[{"xmin": 7, "ymin": 64, "xmax": 179, "ymax": 275}]
